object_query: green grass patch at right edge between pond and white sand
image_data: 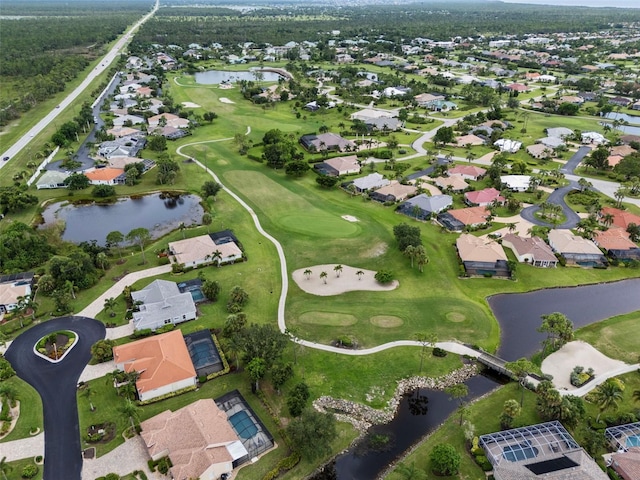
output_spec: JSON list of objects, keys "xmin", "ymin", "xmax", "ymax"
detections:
[{"xmin": 575, "ymin": 311, "xmax": 640, "ymax": 364}]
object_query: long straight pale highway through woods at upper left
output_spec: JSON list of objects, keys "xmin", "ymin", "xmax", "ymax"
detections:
[{"xmin": 0, "ymin": 0, "xmax": 160, "ymax": 169}]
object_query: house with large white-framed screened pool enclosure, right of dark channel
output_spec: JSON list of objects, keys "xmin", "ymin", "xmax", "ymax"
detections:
[{"xmin": 479, "ymin": 421, "xmax": 609, "ymax": 480}]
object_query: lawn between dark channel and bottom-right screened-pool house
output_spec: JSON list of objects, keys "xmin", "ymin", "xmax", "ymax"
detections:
[{"xmin": 386, "ymin": 382, "xmax": 540, "ymax": 480}]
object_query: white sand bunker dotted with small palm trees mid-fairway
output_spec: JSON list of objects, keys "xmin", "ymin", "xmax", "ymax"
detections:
[{"xmin": 291, "ymin": 263, "xmax": 400, "ymax": 297}]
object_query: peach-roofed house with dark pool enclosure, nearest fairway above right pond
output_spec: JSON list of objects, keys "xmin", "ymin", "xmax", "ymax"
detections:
[{"xmin": 456, "ymin": 233, "xmax": 511, "ymax": 277}]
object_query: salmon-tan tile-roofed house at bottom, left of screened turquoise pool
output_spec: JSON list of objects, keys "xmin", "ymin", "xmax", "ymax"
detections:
[{"xmin": 140, "ymin": 398, "xmax": 248, "ymax": 480}]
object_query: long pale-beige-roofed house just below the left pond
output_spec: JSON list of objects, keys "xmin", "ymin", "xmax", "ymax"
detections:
[{"xmin": 169, "ymin": 235, "xmax": 242, "ymax": 267}]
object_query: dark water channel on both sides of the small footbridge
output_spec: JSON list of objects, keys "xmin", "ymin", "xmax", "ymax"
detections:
[{"xmin": 314, "ymin": 278, "xmax": 640, "ymax": 480}]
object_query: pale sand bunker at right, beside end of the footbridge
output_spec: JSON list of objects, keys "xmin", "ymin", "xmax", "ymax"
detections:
[{"xmin": 540, "ymin": 341, "xmax": 626, "ymax": 390}]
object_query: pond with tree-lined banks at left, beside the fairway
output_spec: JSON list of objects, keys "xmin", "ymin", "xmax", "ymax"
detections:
[{"xmin": 41, "ymin": 193, "xmax": 204, "ymax": 245}]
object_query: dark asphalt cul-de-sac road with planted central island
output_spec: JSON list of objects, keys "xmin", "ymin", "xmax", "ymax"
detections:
[{"xmin": 5, "ymin": 316, "xmax": 106, "ymax": 480}]
